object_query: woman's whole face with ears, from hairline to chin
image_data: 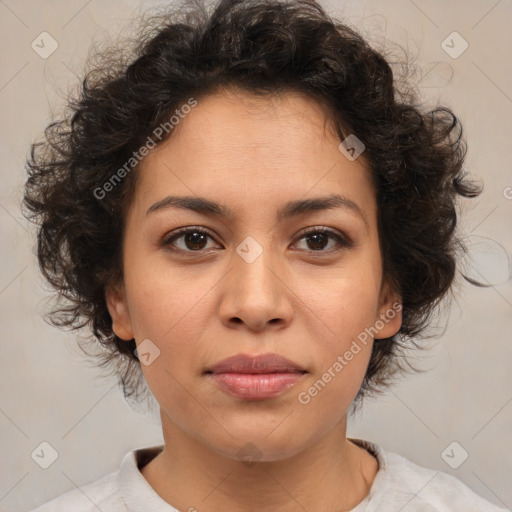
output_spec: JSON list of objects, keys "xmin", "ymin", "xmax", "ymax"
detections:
[{"xmin": 107, "ymin": 92, "xmax": 401, "ymax": 461}]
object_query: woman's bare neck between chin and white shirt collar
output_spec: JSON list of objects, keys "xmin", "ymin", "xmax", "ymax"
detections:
[{"xmin": 142, "ymin": 417, "xmax": 378, "ymax": 512}]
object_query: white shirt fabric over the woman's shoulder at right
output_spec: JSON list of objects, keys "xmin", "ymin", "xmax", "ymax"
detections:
[{"xmin": 350, "ymin": 440, "xmax": 507, "ymax": 512}]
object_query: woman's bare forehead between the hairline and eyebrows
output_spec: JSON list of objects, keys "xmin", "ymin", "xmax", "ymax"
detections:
[{"xmin": 130, "ymin": 87, "xmax": 375, "ymax": 222}]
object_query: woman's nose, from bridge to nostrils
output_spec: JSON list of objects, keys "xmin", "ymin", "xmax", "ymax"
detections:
[{"xmin": 219, "ymin": 239, "xmax": 293, "ymax": 331}]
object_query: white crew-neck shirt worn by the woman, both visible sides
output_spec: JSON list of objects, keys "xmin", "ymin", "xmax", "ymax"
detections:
[{"xmin": 31, "ymin": 438, "xmax": 510, "ymax": 512}]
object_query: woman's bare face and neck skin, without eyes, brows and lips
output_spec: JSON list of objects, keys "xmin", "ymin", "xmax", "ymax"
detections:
[{"xmin": 106, "ymin": 90, "xmax": 401, "ymax": 512}]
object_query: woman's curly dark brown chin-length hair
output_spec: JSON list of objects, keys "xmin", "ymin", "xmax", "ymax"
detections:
[{"xmin": 24, "ymin": 0, "xmax": 481, "ymax": 410}]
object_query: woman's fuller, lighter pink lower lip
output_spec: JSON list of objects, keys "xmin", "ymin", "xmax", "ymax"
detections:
[{"xmin": 211, "ymin": 372, "xmax": 304, "ymax": 400}]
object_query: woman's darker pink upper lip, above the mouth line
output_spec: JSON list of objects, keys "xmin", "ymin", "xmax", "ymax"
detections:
[{"xmin": 206, "ymin": 354, "xmax": 305, "ymax": 373}]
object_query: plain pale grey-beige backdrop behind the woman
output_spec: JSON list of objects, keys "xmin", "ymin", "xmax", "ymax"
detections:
[{"xmin": 0, "ymin": 0, "xmax": 512, "ymax": 512}]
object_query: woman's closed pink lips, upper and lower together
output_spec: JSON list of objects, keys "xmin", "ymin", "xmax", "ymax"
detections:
[{"xmin": 205, "ymin": 354, "xmax": 307, "ymax": 400}]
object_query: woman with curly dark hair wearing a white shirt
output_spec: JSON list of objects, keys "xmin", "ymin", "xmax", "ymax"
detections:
[{"xmin": 25, "ymin": 0, "xmax": 502, "ymax": 512}]
